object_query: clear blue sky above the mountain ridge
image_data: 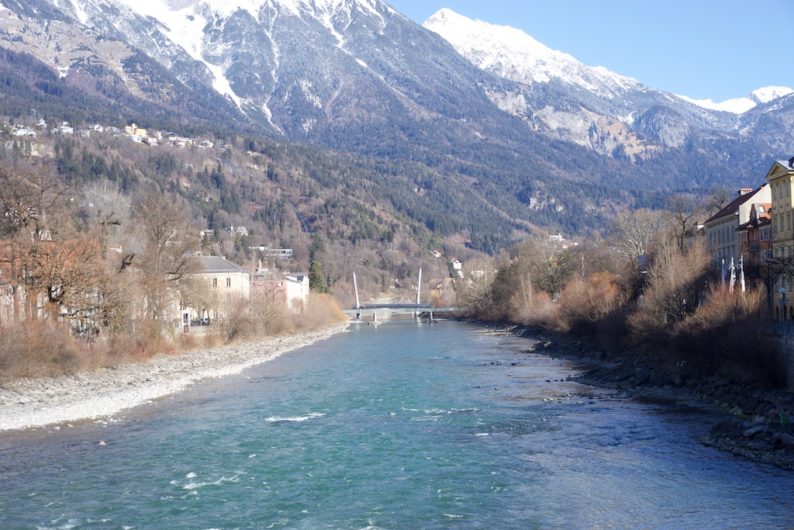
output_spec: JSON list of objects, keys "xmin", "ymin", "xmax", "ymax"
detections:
[{"xmin": 387, "ymin": 0, "xmax": 794, "ymax": 101}]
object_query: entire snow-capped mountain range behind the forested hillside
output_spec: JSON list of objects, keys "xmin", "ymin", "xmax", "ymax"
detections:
[{"xmin": 0, "ymin": 0, "xmax": 794, "ymax": 250}]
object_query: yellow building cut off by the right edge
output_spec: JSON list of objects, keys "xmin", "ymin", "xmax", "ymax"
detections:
[{"xmin": 766, "ymin": 158, "xmax": 794, "ymax": 320}]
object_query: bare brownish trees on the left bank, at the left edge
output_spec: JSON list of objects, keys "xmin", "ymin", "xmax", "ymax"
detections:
[{"xmin": 0, "ymin": 164, "xmax": 204, "ymax": 376}]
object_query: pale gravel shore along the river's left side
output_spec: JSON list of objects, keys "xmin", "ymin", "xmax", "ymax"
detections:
[{"xmin": 0, "ymin": 324, "xmax": 347, "ymax": 431}]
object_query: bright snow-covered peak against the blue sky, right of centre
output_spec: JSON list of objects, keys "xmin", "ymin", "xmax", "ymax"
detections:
[{"xmin": 423, "ymin": 8, "xmax": 640, "ymax": 98}]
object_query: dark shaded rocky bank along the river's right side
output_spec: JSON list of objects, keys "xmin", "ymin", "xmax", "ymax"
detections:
[{"xmin": 513, "ymin": 327, "xmax": 794, "ymax": 470}]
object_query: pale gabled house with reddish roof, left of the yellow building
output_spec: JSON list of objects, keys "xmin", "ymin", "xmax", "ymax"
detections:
[{"xmin": 703, "ymin": 184, "xmax": 772, "ymax": 268}]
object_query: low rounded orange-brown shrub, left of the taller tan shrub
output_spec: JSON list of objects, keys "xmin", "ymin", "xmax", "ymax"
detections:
[{"xmin": 556, "ymin": 272, "xmax": 625, "ymax": 333}]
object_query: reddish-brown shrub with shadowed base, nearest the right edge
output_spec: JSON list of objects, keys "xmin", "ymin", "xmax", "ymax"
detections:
[{"xmin": 672, "ymin": 289, "xmax": 785, "ymax": 387}]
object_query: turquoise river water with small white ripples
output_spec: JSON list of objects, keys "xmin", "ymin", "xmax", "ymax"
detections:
[{"xmin": 0, "ymin": 322, "xmax": 794, "ymax": 529}]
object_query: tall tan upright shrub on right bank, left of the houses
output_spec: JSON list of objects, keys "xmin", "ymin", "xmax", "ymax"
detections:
[{"xmin": 628, "ymin": 241, "xmax": 709, "ymax": 341}]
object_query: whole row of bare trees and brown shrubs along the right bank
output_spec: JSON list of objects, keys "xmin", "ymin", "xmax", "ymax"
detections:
[{"xmin": 463, "ymin": 196, "xmax": 794, "ymax": 385}]
